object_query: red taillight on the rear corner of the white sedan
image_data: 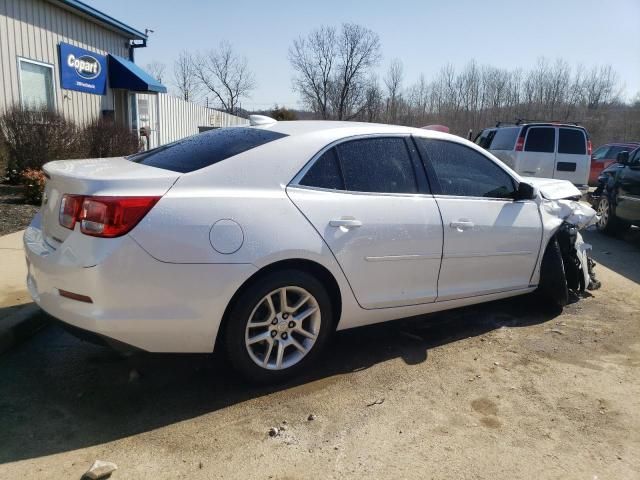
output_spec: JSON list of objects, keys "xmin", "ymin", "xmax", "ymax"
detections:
[{"xmin": 60, "ymin": 195, "xmax": 160, "ymax": 238}]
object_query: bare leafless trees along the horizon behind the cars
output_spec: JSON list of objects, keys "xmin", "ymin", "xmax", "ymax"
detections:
[{"xmin": 148, "ymin": 23, "xmax": 640, "ymax": 144}]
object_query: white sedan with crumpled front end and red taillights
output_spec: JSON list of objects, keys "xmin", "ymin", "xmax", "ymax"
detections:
[{"xmin": 24, "ymin": 117, "xmax": 593, "ymax": 382}]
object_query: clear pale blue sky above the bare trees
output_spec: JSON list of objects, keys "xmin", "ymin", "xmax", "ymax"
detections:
[{"xmin": 84, "ymin": 0, "xmax": 640, "ymax": 109}]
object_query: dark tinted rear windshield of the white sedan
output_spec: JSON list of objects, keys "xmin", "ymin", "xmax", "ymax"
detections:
[{"xmin": 128, "ymin": 127, "xmax": 287, "ymax": 173}]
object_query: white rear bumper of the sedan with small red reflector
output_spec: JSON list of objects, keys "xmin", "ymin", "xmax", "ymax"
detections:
[{"xmin": 24, "ymin": 220, "xmax": 256, "ymax": 352}]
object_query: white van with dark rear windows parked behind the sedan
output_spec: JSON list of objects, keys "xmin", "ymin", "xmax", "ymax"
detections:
[{"xmin": 475, "ymin": 122, "xmax": 591, "ymax": 192}]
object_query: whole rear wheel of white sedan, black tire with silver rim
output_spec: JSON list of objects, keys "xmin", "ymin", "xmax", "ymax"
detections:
[{"xmin": 223, "ymin": 270, "xmax": 334, "ymax": 384}]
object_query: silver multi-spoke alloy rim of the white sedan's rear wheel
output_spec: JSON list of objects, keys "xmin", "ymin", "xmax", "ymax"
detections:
[{"xmin": 245, "ymin": 286, "xmax": 321, "ymax": 370}]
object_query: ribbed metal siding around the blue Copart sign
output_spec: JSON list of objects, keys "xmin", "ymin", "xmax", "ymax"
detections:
[{"xmin": 0, "ymin": 0, "xmax": 128, "ymax": 123}]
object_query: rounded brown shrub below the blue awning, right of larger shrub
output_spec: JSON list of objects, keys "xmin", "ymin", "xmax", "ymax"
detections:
[{"xmin": 82, "ymin": 118, "xmax": 140, "ymax": 158}]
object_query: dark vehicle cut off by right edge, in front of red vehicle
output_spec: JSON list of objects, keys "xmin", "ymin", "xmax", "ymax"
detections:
[{"xmin": 591, "ymin": 148, "xmax": 640, "ymax": 233}]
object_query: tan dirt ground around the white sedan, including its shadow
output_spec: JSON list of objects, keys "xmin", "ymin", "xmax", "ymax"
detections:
[{"xmin": 0, "ymin": 229, "xmax": 640, "ymax": 480}]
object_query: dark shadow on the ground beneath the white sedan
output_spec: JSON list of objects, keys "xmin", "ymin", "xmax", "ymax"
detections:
[{"xmin": 0, "ymin": 295, "xmax": 558, "ymax": 463}]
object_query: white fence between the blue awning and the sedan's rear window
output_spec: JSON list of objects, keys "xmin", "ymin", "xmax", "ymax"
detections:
[{"xmin": 138, "ymin": 93, "xmax": 249, "ymax": 147}]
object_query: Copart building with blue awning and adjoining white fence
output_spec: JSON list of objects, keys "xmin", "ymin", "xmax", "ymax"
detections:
[{"xmin": 0, "ymin": 0, "xmax": 247, "ymax": 146}]
